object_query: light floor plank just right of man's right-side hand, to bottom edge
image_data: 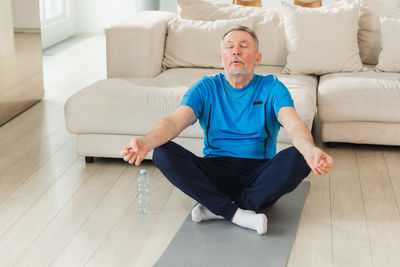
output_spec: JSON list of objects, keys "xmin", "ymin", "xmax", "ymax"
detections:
[{"xmin": 330, "ymin": 148, "xmax": 372, "ymax": 267}]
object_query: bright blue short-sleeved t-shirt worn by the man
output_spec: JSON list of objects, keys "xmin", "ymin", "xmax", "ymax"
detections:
[{"xmin": 181, "ymin": 73, "xmax": 294, "ymax": 159}]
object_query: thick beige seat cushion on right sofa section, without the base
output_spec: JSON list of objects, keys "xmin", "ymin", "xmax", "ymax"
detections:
[{"xmin": 318, "ymin": 65, "xmax": 400, "ymax": 122}]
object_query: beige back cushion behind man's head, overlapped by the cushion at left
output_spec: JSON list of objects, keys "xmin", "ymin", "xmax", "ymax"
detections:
[{"xmin": 176, "ymin": 0, "xmax": 287, "ymax": 66}]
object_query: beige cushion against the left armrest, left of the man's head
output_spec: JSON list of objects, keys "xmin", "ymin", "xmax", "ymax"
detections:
[{"xmin": 163, "ymin": 18, "xmax": 253, "ymax": 69}]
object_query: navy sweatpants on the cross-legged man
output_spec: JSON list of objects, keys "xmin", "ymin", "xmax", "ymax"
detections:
[{"xmin": 153, "ymin": 141, "xmax": 311, "ymax": 220}]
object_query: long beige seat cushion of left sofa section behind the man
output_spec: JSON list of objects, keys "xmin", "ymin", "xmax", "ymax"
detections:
[{"xmin": 65, "ymin": 66, "xmax": 317, "ymax": 147}]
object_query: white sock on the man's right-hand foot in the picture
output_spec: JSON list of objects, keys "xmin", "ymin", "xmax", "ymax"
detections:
[{"xmin": 232, "ymin": 208, "xmax": 268, "ymax": 235}]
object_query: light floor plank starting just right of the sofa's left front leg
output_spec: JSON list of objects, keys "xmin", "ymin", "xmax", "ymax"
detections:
[{"xmin": 16, "ymin": 161, "xmax": 125, "ymax": 267}]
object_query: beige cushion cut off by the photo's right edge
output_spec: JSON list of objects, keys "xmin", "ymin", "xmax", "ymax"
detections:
[{"xmin": 376, "ymin": 17, "xmax": 400, "ymax": 72}]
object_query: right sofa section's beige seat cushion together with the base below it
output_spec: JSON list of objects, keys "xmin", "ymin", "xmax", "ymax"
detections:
[{"xmin": 317, "ymin": 65, "xmax": 400, "ymax": 145}]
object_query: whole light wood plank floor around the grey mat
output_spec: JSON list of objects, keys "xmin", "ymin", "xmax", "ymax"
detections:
[{"xmin": 0, "ymin": 35, "xmax": 400, "ymax": 267}]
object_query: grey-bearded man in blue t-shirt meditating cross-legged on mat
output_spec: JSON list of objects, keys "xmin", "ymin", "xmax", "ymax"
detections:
[{"xmin": 121, "ymin": 26, "xmax": 333, "ymax": 234}]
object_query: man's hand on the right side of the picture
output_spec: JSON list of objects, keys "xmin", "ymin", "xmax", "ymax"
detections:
[{"xmin": 304, "ymin": 147, "xmax": 333, "ymax": 176}]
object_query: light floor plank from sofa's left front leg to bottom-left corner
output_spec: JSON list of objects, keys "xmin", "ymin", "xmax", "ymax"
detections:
[{"xmin": 0, "ymin": 159, "xmax": 97, "ymax": 267}]
